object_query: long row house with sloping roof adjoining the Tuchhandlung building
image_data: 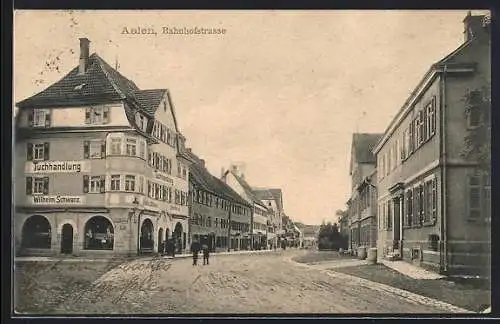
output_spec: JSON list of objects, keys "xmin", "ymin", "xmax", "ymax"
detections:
[{"xmin": 184, "ymin": 149, "xmax": 252, "ymax": 252}]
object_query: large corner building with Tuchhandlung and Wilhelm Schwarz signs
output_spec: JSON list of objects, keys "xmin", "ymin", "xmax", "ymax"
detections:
[{"xmin": 13, "ymin": 38, "xmax": 188, "ymax": 255}]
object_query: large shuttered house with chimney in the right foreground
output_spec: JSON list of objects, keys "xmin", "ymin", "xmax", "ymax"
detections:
[{"xmin": 374, "ymin": 15, "xmax": 491, "ymax": 276}]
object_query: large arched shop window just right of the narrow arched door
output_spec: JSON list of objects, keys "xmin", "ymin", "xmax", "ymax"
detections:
[{"xmin": 83, "ymin": 216, "xmax": 115, "ymax": 250}]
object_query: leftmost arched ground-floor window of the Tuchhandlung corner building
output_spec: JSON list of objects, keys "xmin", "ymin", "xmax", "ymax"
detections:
[{"xmin": 21, "ymin": 215, "xmax": 52, "ymax": 249}]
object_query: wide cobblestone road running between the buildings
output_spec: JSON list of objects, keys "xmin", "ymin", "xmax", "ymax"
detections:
[{"xmin": 56, "ymin": 251, "xmax": 458, "ymax": 314}]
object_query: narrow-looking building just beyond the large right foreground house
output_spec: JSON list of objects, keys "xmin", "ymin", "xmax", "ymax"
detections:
[{"xmin": 347, "ymin": 133, "xmax": 382, "ymax": 251}]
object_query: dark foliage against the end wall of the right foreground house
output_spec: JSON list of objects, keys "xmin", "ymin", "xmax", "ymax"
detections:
[{"xmin": 462, "ymin": 86, "xmax": 491, "ymax": 171}]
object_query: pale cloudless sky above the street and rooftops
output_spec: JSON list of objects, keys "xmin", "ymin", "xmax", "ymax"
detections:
[{"xmin": 13, "ymin": 10, "xmax": 480, "ymax": 224}]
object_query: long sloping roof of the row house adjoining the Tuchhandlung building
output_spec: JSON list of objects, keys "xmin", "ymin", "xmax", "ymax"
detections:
[{"xmin": 182, "ymin": 151, "xmax": 250, "ymax": 206}]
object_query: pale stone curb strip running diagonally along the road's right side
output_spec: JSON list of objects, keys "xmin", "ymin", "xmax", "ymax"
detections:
[{"xmin": 286, "ymin": 257, "xmax": 476, "ymax": 314}]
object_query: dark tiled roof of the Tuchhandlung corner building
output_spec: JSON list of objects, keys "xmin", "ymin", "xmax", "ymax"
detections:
[{"xmin": 17, "ymin": 53, "xmax": 168, "ymax": 129}]
